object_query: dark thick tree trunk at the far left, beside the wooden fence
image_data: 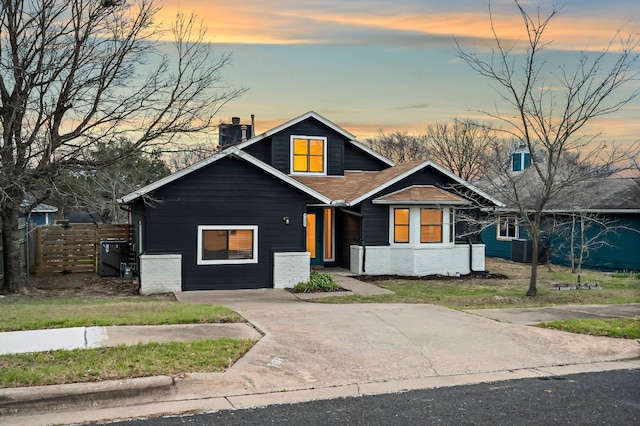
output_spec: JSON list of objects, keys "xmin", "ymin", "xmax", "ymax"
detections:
[{"xmin": 2, "ymin": 205, "xmax": 29, "ymax": 294}]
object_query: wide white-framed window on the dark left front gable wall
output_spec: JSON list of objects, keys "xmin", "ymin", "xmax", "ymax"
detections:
[{"xmin": 198, "ymin": 225, "xmax": 258, "ymax": 265}]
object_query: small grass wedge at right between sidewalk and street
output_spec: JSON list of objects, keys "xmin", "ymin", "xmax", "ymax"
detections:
[{"xmin": 538, "ymin": 317, "xmax": 640, "ymax": 339}]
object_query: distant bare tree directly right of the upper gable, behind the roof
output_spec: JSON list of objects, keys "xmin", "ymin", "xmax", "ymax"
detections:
[{"xmin": 365, "ymin": 130, "xmax": 427, "ymax": 164}]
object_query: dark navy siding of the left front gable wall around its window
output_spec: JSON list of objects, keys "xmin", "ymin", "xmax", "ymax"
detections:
[{"xmin": 142, "ymin": 158, "xmax": 306, "ymax": 290}]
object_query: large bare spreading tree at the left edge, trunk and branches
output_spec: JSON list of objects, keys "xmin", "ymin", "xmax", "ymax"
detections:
[{"xmin": 0, "ymin": 0, "xmax": 242, "ymax": 292}]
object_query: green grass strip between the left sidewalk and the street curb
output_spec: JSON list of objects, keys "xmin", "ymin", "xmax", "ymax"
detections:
[{"xmin": 0, "ymin": 338, "xmax": 254, "ymax": 387}]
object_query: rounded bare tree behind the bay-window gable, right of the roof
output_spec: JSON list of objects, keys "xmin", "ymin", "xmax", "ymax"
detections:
[{"xmin": 424, "ymin": 119, "xmax": 497, "ymax": 180}]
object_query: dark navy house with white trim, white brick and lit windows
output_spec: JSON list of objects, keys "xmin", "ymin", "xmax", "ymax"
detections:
[{"xmin": 119, "ymin": 111, "xmax": 500, "ymax": 293}]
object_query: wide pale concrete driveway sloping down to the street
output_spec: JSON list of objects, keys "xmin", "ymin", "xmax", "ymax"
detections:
[{"xmin": 178, "ymin": 290, "xmax": 640, "ymax": 395}]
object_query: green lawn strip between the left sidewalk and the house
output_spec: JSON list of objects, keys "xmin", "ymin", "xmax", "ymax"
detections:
[{"xmin": 0, "ymin": 297, "xmax": 244, "ymax": 331}]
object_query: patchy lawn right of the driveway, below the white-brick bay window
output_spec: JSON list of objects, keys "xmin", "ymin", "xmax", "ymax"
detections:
[{"xmin": 317, "ymin": 259, "xmax": 640, "ymax": 309}]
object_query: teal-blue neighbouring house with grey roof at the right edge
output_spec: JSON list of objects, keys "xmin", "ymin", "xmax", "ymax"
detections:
[{"xmin": 478, "ymin": 163, "xmax": 640, "ymax": 271}]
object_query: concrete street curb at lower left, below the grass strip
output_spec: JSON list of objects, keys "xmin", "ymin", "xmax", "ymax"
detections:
[{"xmin": 0, "ymin": 376, "xmax": 175, "ymax": 416}]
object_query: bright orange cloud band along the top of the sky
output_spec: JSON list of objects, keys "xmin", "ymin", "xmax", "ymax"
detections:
[{"xmin": 158, "ymin": 0, "xmax": 636, "ymax": 50}]
